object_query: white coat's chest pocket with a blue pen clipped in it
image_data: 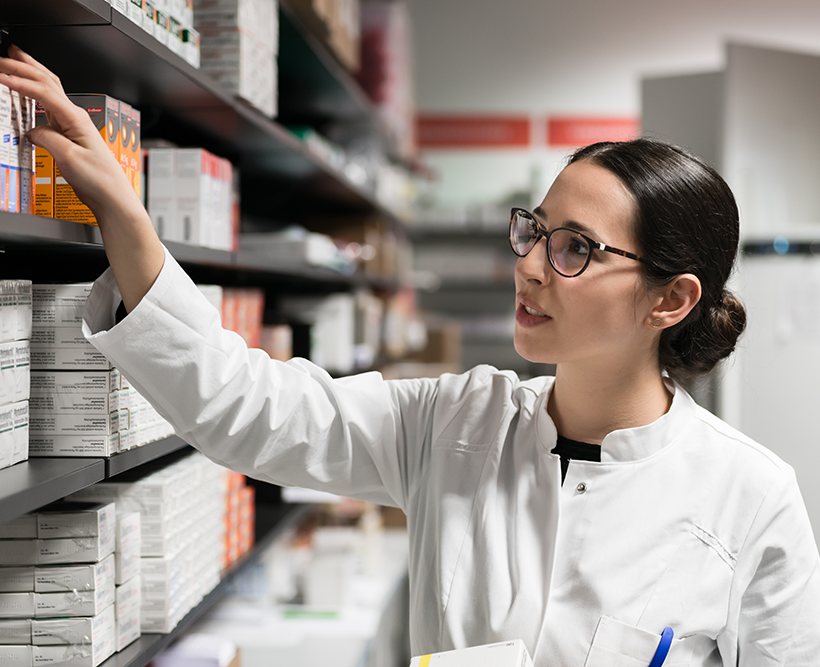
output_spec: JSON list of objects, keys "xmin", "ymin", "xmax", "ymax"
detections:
[{"xmin": 584, "ymin": 616, "xmax": 692, "ymax": 667}]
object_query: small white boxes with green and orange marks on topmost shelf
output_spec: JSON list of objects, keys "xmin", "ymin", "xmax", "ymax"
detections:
[{"xmin": 111, "ymin": 0, "xmax": 199, "ymax": 67}]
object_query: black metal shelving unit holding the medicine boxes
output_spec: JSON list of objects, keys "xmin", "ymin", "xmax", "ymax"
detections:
[{"xmin": 0, "ymin": 0, "xmax": 405, "ymax": 667}]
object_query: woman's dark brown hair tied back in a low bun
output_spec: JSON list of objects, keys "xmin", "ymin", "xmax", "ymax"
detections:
[{"xmin": 569, "ymin": 139, "xmax": 746, "ymax": 380}]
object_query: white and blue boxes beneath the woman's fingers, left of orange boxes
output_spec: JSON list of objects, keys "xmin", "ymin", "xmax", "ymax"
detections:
[{"xmin": 0, "ymin": 84, "xmax": 34, "ymax": 213}]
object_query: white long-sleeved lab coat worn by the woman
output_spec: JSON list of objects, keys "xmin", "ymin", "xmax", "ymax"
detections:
[{"xmin": 85, "ymin": 249, "xmax": 820, "ymax": 667}]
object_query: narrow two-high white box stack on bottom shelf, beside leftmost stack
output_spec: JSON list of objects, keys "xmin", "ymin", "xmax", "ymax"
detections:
[{"xmin": 114, "ymin": 511, "xmax": 142, "ymax": 651}]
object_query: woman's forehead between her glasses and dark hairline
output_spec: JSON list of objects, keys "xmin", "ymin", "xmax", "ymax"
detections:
[{"xmin": 535, "ymin": 160, "xmax": 636, "ymax": 245}]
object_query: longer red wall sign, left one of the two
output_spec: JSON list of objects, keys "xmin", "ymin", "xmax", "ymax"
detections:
[{"xmin": 416, "ymin": 115, "xmax": 532, "ymax": 148}]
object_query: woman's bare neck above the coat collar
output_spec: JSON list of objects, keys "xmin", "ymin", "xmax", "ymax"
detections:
[{"xmin": 547, "ymin": 364, "xmax": 672, "ymax": 444}]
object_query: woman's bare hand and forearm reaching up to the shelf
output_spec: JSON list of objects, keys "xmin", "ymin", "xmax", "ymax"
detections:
[{"xmin": 0, "ymin": 46, "xmax": 165, "ymax": 312}]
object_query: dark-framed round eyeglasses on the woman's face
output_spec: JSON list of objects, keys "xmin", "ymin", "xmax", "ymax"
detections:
[{"xmin": 510, "ymin": 208, "xmax": 654, "ymax": 278}]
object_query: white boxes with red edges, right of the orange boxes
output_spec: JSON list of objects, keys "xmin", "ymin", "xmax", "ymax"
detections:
[{"xmin": 146, "ymin": 147, "xmax": 239, "ymax": 250}]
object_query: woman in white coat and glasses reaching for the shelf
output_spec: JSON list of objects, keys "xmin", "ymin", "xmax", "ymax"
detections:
[{"xmin": 0, "ymin": 44, "xmax": 820, "ymax": 667}]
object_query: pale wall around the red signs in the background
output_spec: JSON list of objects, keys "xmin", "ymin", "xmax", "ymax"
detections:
[{"xmin": 410, "ymin": 0, "xmax": 820, "ymax": 208}]
